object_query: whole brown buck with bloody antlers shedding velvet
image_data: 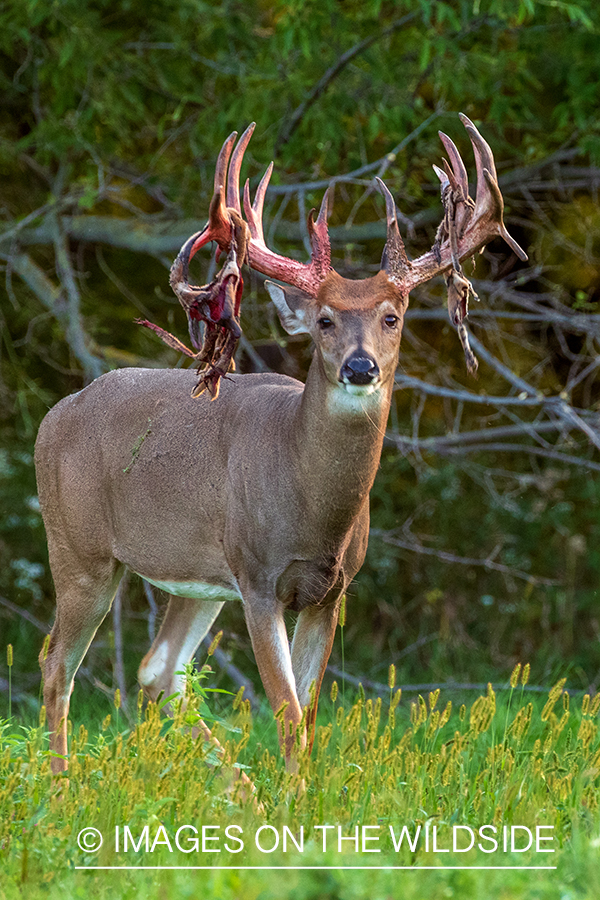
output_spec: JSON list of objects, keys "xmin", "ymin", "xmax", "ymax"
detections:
[{"xmin": 35, "ymin": 114, "xmax": 527, "ymax": 774}]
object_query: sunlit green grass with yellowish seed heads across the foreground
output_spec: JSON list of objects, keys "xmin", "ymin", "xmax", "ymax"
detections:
[{"xmin": 0, "ymin": 667, "xmax": 600, "ymax": 900}]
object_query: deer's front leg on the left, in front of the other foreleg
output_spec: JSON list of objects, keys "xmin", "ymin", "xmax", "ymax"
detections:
[{"xmin": 242, "ymin": 590, "xmax": 306, "ymax": 771}]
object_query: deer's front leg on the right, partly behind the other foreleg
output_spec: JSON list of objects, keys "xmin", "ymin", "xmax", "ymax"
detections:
[{"xmin": 292, "ymin": 595, "xmax": 341, "ymax": 750}]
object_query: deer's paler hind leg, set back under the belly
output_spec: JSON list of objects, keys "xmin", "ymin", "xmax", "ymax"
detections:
[{"xmin": 138, "ymin": 596, "xmax": 224, "ymax": 737}]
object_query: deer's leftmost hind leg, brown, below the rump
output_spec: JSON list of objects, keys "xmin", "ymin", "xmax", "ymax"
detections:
[{"xmin": 40, "ymin": 553, "xmax": 123, "ymax": 774}]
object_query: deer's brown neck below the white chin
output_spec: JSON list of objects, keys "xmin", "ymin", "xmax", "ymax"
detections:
[{"xmin": 294, "ymin": 354, "xmax": 393, "ymax": 528}]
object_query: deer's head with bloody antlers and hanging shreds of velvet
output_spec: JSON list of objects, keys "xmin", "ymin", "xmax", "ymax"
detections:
[{"xmin": 171, "ymin": 114, "xmax": 527, "ymax": 397}]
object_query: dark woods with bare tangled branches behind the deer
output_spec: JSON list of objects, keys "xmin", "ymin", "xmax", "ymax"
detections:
[{"xmin": 0, "ymin": 0, "xmax": 600, "ymax": 716}]
